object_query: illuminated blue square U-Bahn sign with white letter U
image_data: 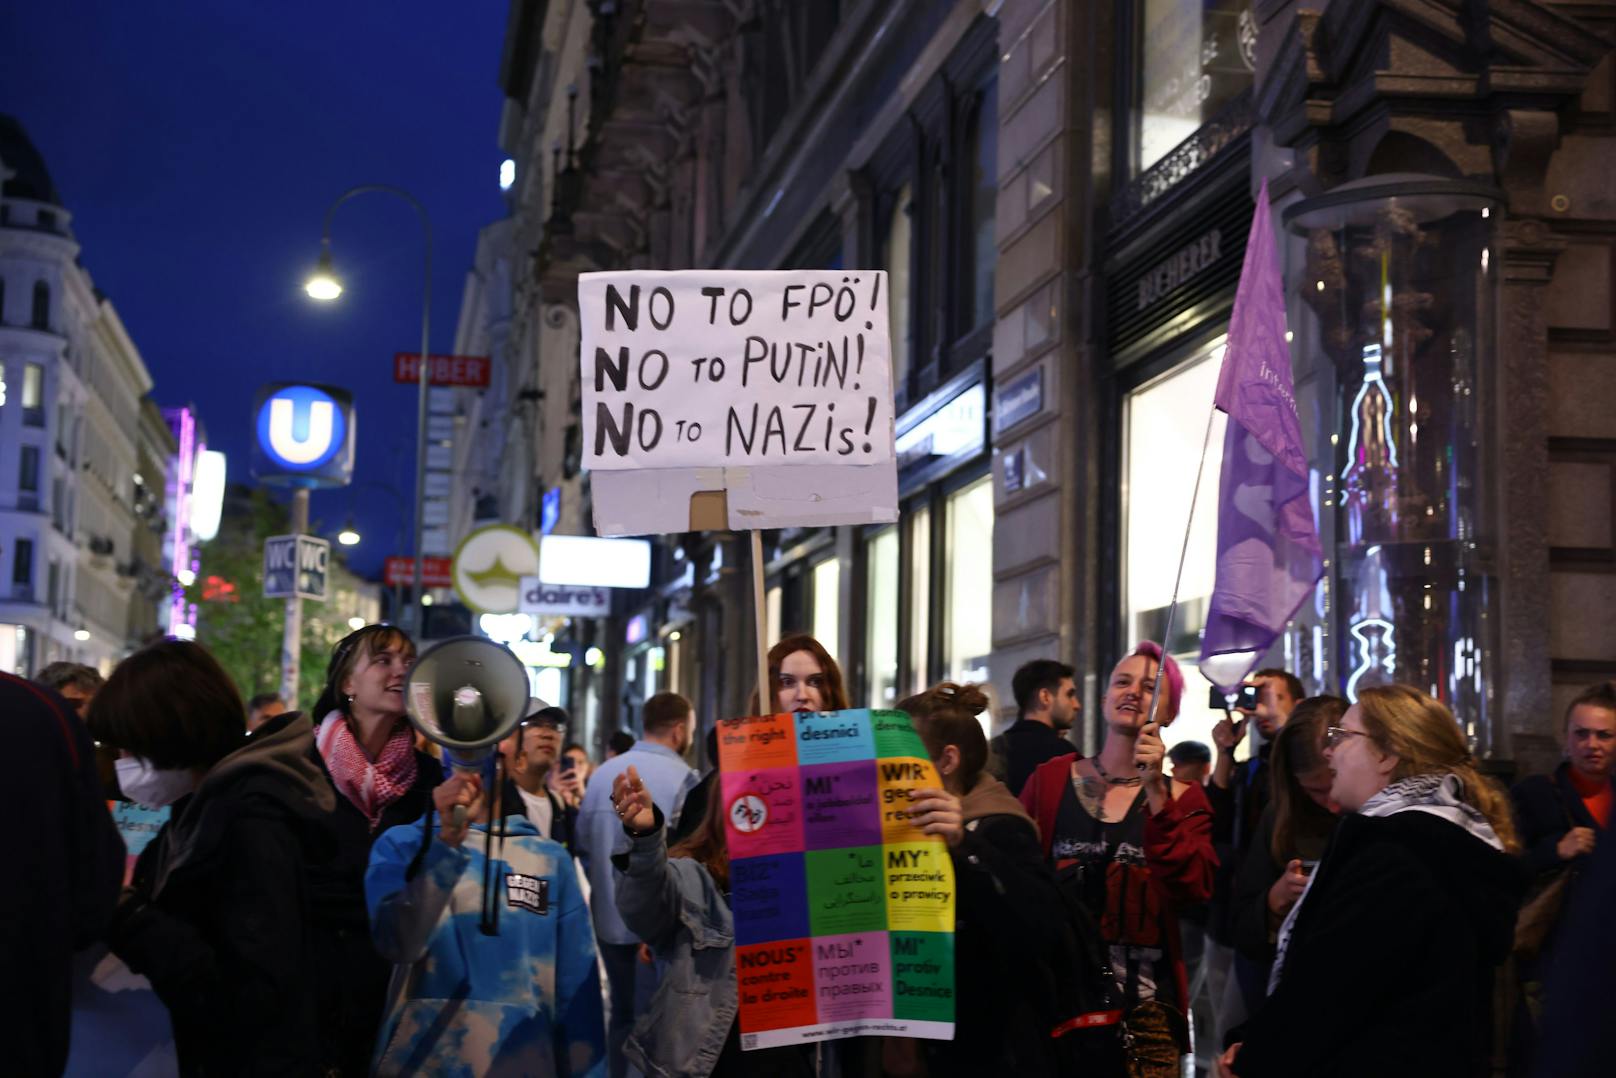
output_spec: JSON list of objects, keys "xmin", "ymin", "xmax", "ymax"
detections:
[{"xmin": 252, "ymin": 381, "xmax": 354, "ymax": 486}]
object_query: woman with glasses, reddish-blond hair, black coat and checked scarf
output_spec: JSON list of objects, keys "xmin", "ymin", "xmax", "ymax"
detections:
[{"xmin": 1218, "ymin": 685, "xmax": 1526, "ymax": 1078}]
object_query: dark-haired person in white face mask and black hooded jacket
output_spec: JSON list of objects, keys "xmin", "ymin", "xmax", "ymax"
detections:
[{"xmin": 89, "ymin": 640, "xmax": 336, "ymax": 1075}]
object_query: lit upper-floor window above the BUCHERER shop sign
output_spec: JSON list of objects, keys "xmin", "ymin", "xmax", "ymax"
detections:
[{"xmin": 1133, "ymin": 0, "xmax": 1257, "ymax": 173}]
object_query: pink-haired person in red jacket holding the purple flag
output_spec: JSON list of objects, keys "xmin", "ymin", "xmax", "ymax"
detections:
[{"xmin": 1021, "ymin": 640, "xmax": 1217, "ymax": 1078}]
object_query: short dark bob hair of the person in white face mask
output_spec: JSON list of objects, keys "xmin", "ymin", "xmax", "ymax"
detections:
[{"xmin": 87, "ymin": 640, "xmax": 247, "ymax": 771}]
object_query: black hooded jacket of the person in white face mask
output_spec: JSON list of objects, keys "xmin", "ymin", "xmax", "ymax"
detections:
[{"xmin": 108, "ymin": 714, "xmax": 333, "ymax": 1075}]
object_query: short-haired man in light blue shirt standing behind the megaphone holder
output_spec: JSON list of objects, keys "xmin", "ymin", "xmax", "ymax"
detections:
[{"xmin": 577, "ymin": 692, "xmax": 696, "ymax": 1078}]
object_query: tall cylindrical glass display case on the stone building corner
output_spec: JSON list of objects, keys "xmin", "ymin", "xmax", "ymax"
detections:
[{"xmin": 1286, "ymin": 176, "xmax": 1500, "ymax": 753}]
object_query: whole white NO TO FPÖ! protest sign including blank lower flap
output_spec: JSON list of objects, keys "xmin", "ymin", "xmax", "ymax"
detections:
[{"xmin": 579, "ymin": 270, "xmax": 897, "ymax": 535}]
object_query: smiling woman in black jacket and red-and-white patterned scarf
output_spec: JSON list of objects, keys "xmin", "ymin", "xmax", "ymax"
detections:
[{"xmin": 303, "ymin": 625, "xmax": 443, "ymax": 1075}]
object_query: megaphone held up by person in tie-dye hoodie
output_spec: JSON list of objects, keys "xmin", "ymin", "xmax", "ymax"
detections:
[{"xmin": 404, "ymin": 637, "xmax": 528, "ymax": 827}]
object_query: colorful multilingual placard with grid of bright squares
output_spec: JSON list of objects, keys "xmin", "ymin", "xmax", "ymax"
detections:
[{"xmin": 719, "ymin": 711, "xmax": 955, "ymax": 1049}]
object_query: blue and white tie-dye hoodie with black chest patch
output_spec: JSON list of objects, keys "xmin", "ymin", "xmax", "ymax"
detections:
[{"xmin": 365, "ymin": 816, "xmax": 606, "ymax": 1078}]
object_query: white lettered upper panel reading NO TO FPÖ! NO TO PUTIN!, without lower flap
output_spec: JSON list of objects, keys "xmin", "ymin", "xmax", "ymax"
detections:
[{"xmin": 579, "ymin": 270, "xmax": 894, "ymax": 470}]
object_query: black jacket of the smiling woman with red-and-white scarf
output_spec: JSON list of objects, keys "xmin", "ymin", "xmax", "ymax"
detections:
[{"xmin": 302, "ymin": 724, "xmax": 443, "ymax": 1075}]
